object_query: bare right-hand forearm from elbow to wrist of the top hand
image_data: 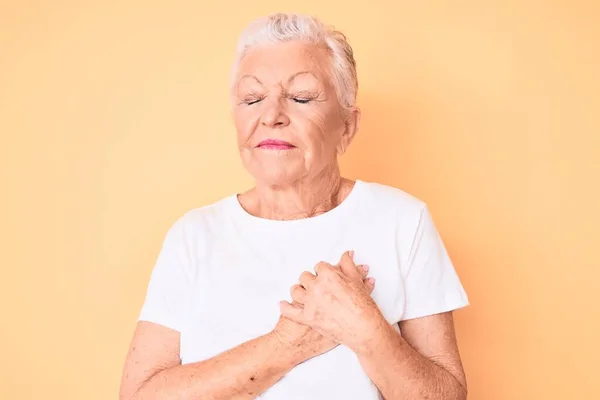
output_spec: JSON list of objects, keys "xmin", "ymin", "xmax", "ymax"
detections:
[{"xmin": 357, "ymin": 324, "xmax": 466, "ymax": 400}]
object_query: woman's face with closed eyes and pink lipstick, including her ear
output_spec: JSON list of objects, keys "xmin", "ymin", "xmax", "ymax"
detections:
[{"xmin": 233, "ymin": 41, "xmax": 358, "ymax": 185}]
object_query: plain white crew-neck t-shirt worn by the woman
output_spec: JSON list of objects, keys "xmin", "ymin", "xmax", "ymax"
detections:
[{"xmin": 139, "ymin": 180, "xmax": 468, "ymax": 400}]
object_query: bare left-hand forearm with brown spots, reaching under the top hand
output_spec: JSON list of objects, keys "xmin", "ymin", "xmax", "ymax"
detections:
[{"xmin": 131, "ymin": 334, "xmax": 302, "ymax": 400}]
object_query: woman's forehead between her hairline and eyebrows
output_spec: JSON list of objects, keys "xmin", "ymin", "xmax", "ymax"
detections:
[{"xmin": 237, "ymin": 41, "xmax": 329, "ymax": 86}]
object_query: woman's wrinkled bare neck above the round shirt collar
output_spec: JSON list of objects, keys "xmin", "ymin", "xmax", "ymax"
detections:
[{"xmin": 247, "ymin": 164, "xmax": 347, "ymax": 220}]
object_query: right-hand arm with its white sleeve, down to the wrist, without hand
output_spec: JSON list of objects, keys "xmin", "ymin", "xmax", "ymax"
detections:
[{"xmin": 355, "ymin": 206, "xmax": 468, "ymax": 400}]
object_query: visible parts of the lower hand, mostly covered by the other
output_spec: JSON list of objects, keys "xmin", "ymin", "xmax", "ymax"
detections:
[{"xmin": 271, "ymin": 265, "xmax": 375, "ymax": 363}]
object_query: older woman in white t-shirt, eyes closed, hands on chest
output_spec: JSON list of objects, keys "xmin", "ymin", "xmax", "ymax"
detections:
[{"xmin": 120, "ymin": 14, "xmax": 468, "ymax": 400}]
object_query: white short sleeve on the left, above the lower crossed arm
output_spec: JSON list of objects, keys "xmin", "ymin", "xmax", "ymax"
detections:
[{"xmin": 138, "ymin": 221, "xmax": 191, "ymax": 332}]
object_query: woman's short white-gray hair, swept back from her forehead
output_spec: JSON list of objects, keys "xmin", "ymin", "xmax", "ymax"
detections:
[{"xmin": 231, "ymin": 13, "xmax": 358, "ymax": 110}]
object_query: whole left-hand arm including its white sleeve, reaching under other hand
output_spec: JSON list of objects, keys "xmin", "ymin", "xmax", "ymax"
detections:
[{"xmin": 119, "ymin": 218, "xmax": 310, "ymax": 400}]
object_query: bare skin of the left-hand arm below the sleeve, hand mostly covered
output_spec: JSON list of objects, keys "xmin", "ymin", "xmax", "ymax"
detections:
[{"xmin": 119, "ymin": 321, "xmax": 323, "ymax": 400}]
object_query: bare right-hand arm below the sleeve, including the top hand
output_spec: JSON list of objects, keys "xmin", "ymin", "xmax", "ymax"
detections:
[{"xmin": 281, "ymin": 253, "xmax": 466, "ymax": 400}]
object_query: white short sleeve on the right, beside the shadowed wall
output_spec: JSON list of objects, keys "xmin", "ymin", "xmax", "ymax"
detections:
[{"xmin": 402, "ymin": 205, "xmax": 469, "ymax": 320}]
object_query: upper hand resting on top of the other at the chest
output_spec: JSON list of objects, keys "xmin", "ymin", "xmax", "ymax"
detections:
[{"xmin": 281, "ymin": 252, "xmax": 385, "ymax": 351}]
